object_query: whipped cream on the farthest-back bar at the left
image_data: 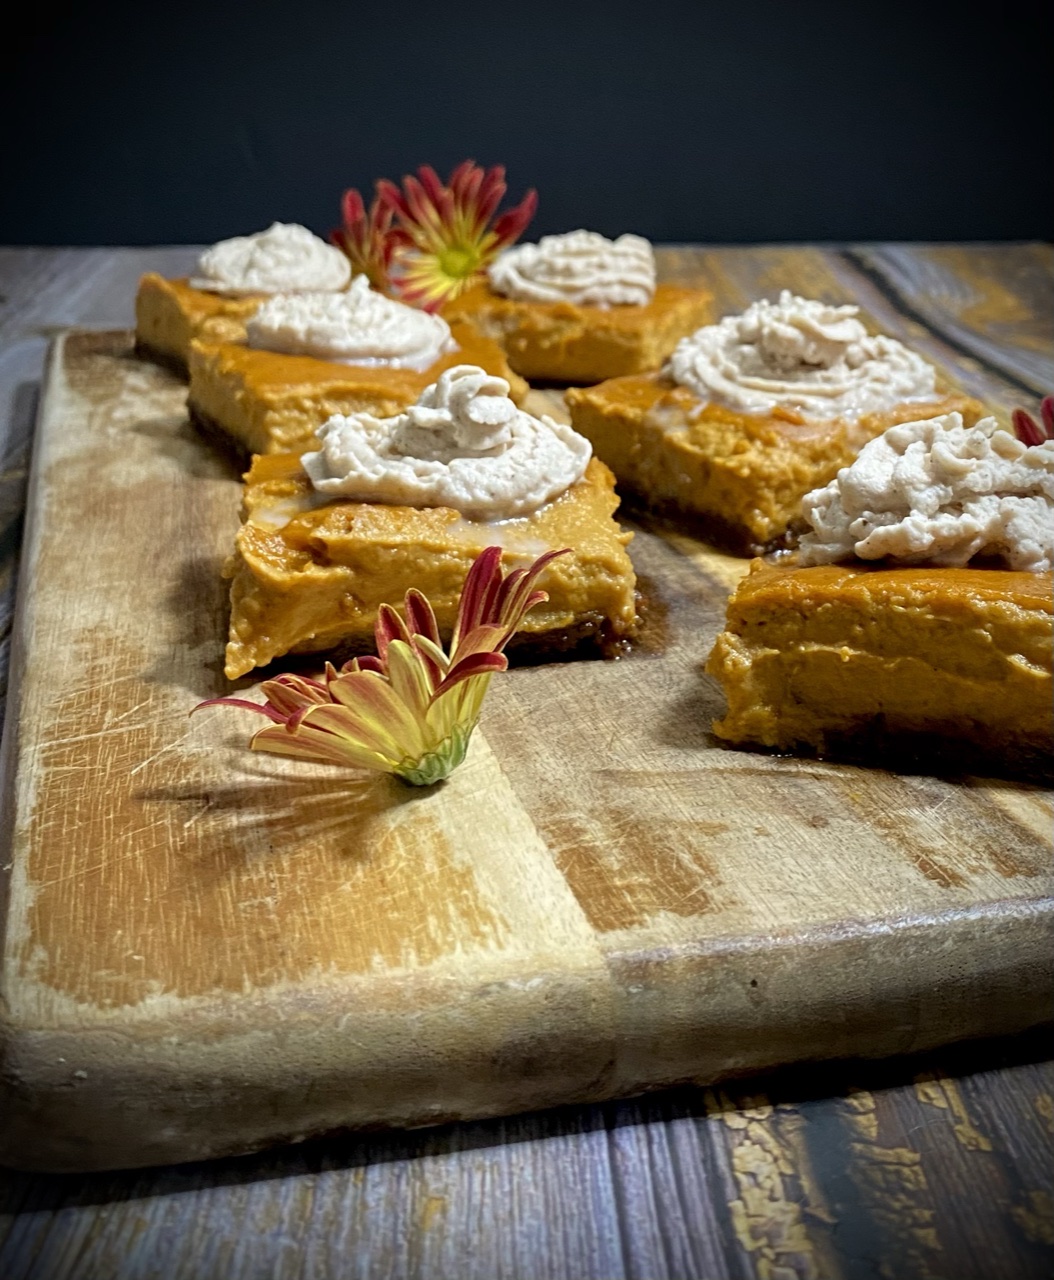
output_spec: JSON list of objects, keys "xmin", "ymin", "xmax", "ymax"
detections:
[{"xmin": 191, "ymin": 223, "xmax": 351, "ymax": 293}]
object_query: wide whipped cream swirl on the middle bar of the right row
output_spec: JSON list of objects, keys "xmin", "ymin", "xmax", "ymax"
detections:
[{"xmin": 667, "ymin": 289, "xmax": 936, "ymax": 420}]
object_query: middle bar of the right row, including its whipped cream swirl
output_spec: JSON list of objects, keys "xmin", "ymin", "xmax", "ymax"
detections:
[{"xmin": 566, "ymin": 293, "xmax": 984, "ymax": 554}]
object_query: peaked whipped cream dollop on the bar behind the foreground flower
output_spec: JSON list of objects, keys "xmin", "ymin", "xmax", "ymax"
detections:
[{"xmin": 301, "ymin": 365, "xmax": 590, "ymax": 520}]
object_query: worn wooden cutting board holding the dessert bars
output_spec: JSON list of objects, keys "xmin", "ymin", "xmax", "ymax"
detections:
[{"xmin": 0, "ymin": 325, "xmax": 1054, "ymax": 1170}]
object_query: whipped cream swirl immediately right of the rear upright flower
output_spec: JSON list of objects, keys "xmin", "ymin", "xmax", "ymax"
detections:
[{"xmin": 488, "ymin": 232, "xmax": 656, "ymax": 307}]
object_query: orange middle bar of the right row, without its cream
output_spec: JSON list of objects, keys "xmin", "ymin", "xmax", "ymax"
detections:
[{"xmin": 566, "ymin": 372, "xmax": 985, "ymax": 554}]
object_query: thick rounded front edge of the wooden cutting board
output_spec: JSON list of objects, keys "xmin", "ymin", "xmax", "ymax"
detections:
[{"xmin": 0, "ymin": 899, "xmax": 1054, "ymax": 1172}]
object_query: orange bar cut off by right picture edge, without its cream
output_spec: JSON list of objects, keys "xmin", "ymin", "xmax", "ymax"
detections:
[{"xmin": 707, "ymin": 561, "xmax": 1054, "ymax": 776}]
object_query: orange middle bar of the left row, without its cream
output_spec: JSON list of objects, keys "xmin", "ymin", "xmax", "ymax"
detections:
[{"xmin": 187, "ymin": 321, "xmax": 529, "ymax": 458}]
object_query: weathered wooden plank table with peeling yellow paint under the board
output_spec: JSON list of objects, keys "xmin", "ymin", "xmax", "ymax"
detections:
[{"xmin": 0, "ymin": 244, "xmax": 1054, "ymax": 1280}]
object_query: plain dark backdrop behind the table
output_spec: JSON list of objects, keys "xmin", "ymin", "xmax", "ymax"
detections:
[{"xmin": 0, "ymin": 0, "xmax": 1054, "ymax": 244}]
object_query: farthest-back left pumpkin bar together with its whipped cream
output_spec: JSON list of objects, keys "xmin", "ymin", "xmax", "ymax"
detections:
[{"xmin": 136, "ymin": 223, "xmax": 351, "ymax": 378}]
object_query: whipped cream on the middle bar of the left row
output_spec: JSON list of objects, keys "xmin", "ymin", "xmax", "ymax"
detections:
[{"xmin": 246, "ymin": 275, "xmax": 457, "ymax": 372}]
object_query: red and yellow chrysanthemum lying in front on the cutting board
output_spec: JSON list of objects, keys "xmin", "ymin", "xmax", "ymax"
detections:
[{"xmin": 195, "ymin": 547, "xmax": 565, "ymax": 786}]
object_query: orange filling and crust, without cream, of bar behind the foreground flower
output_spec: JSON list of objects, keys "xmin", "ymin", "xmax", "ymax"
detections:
[{"xmin": 224, "ymin": 454, "xmax": 636, "ymax": 680}]
